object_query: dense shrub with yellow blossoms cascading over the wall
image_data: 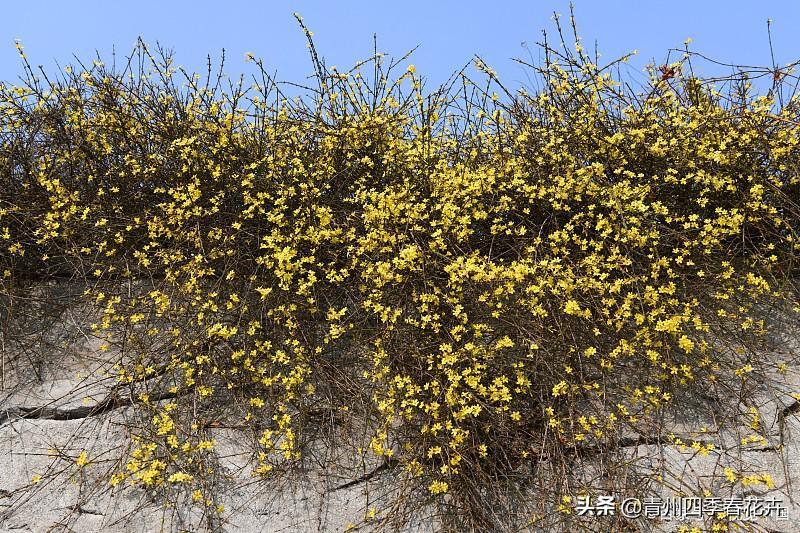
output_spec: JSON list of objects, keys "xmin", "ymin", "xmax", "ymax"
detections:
[{"xmin": 0, "ymin": 15, "xmax": 800, "ymax": 530}]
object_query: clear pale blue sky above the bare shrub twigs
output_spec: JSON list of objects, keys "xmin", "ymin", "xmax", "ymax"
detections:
[{"xmin": 0, "ymin": 0, "xmax": 800, "ymax": 91}]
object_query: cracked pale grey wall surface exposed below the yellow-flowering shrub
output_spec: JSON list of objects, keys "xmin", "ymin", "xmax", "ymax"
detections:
[{"xmin": 0, "ymin": 296, "xmax": 800, "ymax": 533}]
